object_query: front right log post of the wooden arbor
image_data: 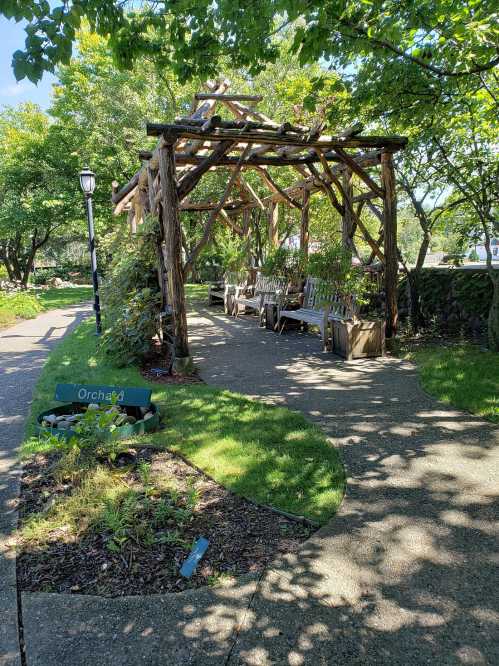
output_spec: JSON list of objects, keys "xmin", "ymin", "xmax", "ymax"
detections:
[{"xmin": 381, "ymin": 152, "xmax": 398, "ymax": 337}]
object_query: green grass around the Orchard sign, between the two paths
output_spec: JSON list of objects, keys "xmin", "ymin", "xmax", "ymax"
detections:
[{"xmin": 22, "ymin": 318, "xmax": 345, "ymax": 524}]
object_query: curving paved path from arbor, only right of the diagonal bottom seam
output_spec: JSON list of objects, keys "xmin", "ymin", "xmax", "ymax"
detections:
[{"xmin": 190, "ymin": 310, "xmax": 499, "ymax": 666}]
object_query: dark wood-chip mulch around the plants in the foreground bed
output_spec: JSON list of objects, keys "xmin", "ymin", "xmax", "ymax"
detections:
[{"xmin": 18, "ymin": 449, "xmax": 312, "ymax": 597}]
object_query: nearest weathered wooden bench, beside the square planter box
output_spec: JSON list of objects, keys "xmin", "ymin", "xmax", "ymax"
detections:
[{"xmin": 277, "ymin": 278, "xmax": 356, "ymax": 349}]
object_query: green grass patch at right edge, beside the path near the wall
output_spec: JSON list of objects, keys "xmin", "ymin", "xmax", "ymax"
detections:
[{"xmin": 407, "ymin": 343, "xmax": 499, "ymax": 423}]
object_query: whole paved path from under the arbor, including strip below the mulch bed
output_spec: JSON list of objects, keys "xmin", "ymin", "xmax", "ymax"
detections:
[{"xmin": 11, "ymin": 310, "xmax": 499, "ymax": 666}]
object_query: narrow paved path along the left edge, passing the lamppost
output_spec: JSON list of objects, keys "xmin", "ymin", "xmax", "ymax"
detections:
[{"xmin": 0, "ymin": 305, "xmax": 91, "ymax": 666}]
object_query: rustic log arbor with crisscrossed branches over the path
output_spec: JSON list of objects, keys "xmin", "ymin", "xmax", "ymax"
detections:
[{"xmin": 112, "ymin": 80, "xmax": 407, "ymax": 370}]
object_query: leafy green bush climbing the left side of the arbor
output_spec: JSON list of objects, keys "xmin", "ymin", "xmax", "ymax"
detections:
[{"xmin": 101, "ymin": 231, "xmax": 161, "ymax": 366}]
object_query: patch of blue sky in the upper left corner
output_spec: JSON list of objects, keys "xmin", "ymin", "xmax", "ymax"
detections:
[{"xmin": 0, "ymin": 16, "xmax": 56, "ymax": 109}]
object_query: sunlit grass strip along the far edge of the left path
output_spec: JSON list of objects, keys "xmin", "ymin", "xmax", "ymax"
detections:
[{"xmin": 0, "ymin": 287, "xmax": 92, "ymax": 328}]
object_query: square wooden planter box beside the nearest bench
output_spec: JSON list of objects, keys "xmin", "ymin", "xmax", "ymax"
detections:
[{"xmin": 332, "ymin": 319, "xmax": 385, "ymax": 361}]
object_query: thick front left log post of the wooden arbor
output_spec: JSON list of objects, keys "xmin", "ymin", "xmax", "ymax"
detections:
[{"xmin": 159, "ymin": 137, "xmax": 192, "ymax": 372}]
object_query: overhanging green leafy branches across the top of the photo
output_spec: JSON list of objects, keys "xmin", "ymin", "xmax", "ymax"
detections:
[{"xmin": 1, "ymin": 0, "xmax": 499, "ymax": 81}]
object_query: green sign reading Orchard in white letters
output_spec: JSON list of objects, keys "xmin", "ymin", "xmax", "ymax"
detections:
[{"xmin": 55, "ymin": 384, "xmax": 151, "ymax": 407}]
